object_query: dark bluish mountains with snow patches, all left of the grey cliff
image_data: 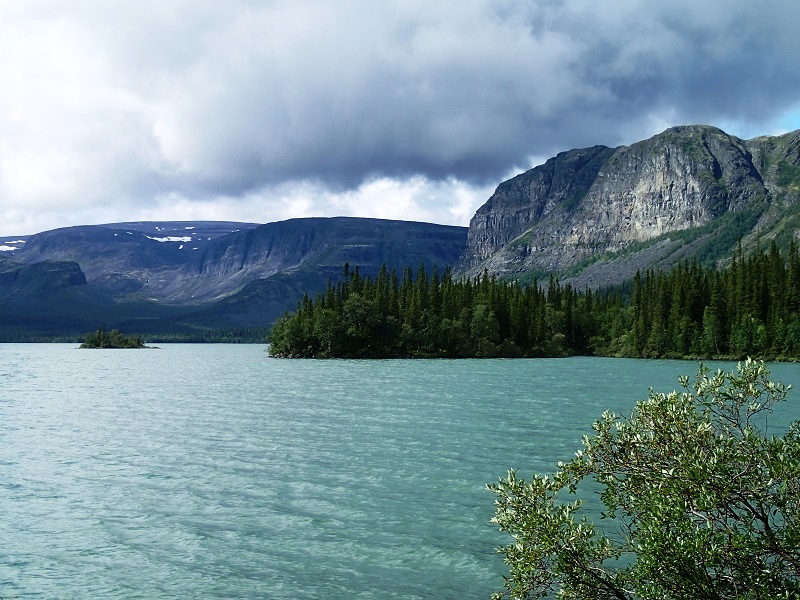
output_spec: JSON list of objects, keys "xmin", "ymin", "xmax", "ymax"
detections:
[{"xmin": 0, "ymin": 217, "xmax": 466, "ymax": 341}]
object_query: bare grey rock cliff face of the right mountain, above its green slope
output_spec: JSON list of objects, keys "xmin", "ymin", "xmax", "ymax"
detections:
[{"xmin": 461, "ymin": 125, "xmax": 800, "ymax": 275}]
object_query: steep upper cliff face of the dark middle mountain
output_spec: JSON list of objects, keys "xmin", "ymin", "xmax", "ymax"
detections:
[{"xmin": 162, "ymin": 217, "xmax": 466, "ymax": 301}]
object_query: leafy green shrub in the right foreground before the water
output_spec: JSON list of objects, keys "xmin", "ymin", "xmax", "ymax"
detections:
[{"xmin": 487, "ymin": 360, "xmax": 800, "ymax": 600}]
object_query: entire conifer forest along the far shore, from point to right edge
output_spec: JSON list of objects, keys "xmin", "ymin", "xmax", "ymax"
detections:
[{"xmin": 269, "ymin": 243, "xmax": 800, "ymax": 360}]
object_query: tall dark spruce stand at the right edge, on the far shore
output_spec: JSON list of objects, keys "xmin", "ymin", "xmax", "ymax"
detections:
[{"xmin": 623, "ymin": 239, "xmax": 800, "ymax": 359}]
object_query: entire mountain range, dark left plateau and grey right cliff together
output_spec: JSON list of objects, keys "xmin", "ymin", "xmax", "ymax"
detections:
[{"xmin": 6, "ymin": 125, "xmax": 800, "ymax": 341}]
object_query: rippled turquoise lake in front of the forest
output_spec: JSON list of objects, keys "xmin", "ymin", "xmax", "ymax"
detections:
[{"xmin": 0, "ymin": 344, "xmax": 800, "ymax": 600}]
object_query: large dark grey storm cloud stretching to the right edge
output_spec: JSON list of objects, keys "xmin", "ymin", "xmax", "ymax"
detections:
[{"xmin": 138, "ymin": 1, "xmax": 800, "ymax": 193}]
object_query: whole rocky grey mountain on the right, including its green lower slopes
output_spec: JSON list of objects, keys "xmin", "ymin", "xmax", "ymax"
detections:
[{"xmin": 460, "ymin": 125, "xmax": 800, "ymax": 287}]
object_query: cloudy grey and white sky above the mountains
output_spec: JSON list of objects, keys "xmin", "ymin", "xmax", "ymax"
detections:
[{"xmin": 0, "ymin": 0, "xmax": 800, "ymax": 241}]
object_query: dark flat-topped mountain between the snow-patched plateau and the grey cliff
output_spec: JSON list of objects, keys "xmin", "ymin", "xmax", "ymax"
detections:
[{"xmin": 137, "ymin": 217, "xmax": 467, "ymax": 336}]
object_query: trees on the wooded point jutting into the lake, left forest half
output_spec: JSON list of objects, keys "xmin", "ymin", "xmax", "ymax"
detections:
[{"xmin": 269, "ymin": 265, "xmax": 605, "ymax": 358}]
